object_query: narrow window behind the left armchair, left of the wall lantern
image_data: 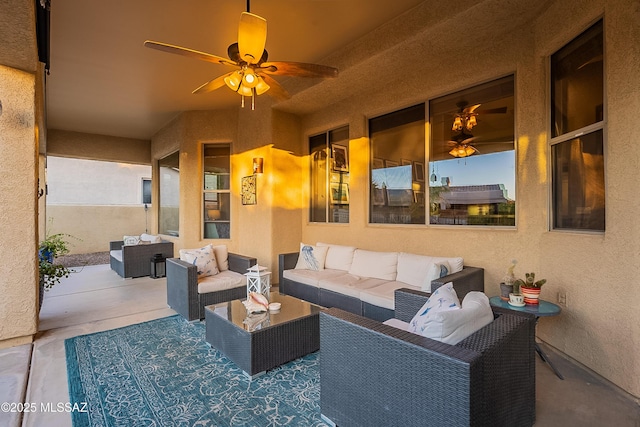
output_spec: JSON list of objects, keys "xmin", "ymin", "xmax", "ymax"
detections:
[{"xmin": 203, "ymin": 144, "xmax": 231, "ymax": 239}]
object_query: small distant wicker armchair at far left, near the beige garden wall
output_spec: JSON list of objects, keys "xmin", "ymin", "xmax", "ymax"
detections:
[{"xmin": 109, "ymin": 240, "xmax": 173, "ymax": 278}]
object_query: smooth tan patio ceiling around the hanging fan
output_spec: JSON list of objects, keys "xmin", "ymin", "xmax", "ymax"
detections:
[{"xmin": 46, "ymin": 0, "xmax": 422, "ymax": 139}]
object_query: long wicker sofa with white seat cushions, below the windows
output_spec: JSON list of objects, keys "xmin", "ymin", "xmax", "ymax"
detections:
[{"xmin": 278, "ymin": 243, "xmax": 484, "ymax": 321}]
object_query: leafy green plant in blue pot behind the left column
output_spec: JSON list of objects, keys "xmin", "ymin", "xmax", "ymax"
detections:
[{"xmin": 38, "ymin": 233, "xmax": 72, "ymax": 307}]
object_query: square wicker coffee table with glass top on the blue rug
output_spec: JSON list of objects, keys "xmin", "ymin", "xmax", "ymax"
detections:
[{"xmin": 204, "ymin": 292, "xmax": 322, "ymax": 377}]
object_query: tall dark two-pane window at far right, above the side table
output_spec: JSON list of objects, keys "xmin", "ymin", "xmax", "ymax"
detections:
[{"xmin": 551, "ymin": 21, "xmax": 605, "ymax": 231}]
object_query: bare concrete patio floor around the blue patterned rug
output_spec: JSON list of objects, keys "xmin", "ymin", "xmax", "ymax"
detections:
[{"xmin": 0, "ymin": 265, "xmax": 640, "ymax": 427}]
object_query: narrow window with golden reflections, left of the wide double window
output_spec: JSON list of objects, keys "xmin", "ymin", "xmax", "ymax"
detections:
[{"xmin": 309, "ymin": 126, "xmax": 349, "ymax": 223}]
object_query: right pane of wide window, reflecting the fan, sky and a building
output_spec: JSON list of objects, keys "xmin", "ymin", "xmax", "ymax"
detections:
[{"xmin": 428, "ymin": 76, "xmax": 516, "ymax": 226}]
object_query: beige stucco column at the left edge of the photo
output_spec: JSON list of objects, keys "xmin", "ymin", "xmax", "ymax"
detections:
[{"xmin": 0, "ymin": 65, "xmax": 38, "ymax": 348}]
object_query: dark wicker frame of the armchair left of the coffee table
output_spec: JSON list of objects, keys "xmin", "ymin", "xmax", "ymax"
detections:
[{"xmin": 167, "ymin": 253, "xmax": 257, "ymax": 320}]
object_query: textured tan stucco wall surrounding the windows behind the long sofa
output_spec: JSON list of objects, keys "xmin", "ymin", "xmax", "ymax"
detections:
[{"xmin": 291, "ymin": 0, "xmax": 640, "ymax": 396}]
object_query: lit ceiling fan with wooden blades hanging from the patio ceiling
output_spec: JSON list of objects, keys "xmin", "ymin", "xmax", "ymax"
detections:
[{"xmin": 144, "ymin": 0, "xmax": 338, "ymax": 110}]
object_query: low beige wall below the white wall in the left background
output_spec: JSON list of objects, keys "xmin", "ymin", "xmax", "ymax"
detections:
[{"xmin": 47, "ymin": 205, "xmax": 153, "ymax": 254}]
